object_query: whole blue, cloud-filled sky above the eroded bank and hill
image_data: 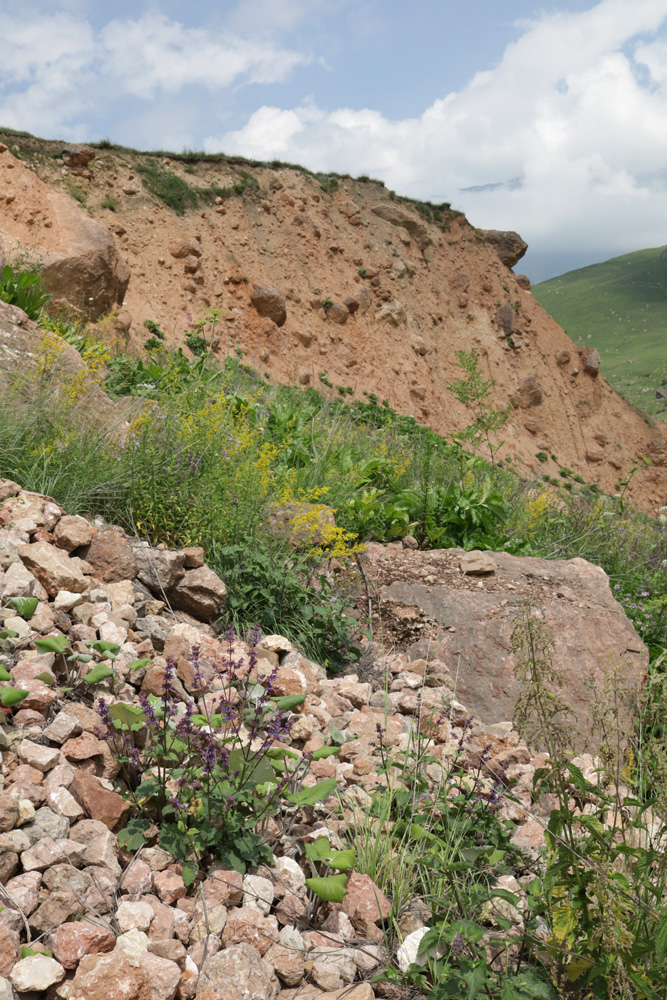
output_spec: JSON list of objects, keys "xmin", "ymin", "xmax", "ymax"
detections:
[{"xmin": 0, "ymin": 0, "xmax": 667, "ymax": 282}]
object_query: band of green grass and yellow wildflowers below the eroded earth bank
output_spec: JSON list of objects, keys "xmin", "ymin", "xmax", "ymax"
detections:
[{"xmin": 0, "ymin": 296, "xmax": 667, "ymax": 663}]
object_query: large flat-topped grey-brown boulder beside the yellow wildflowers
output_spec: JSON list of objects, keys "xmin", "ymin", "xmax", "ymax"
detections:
[{"xmin": 365, "ymin": 545, "xmax": 648, "ymax": 745}]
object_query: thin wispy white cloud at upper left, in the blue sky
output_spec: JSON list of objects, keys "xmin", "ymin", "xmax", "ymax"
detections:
[{"xmin": 0, "ymin": 10, "xmax": 309, "ymax": 138}]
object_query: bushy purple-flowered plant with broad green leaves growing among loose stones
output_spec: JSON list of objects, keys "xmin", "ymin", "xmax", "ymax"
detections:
[{"xmin": 98, "ymin": 629, "xmax": 337, "ymax": 882}]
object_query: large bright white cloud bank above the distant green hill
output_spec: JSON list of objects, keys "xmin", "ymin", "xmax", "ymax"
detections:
[{"xmin": 205, "ymin": 0, "xmax": 667, "ymax": 278}]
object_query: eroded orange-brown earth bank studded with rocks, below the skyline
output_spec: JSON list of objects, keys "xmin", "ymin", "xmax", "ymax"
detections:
[{"xmin": 0, "ymin": 132, "xmax": 667, "ymax": 510}]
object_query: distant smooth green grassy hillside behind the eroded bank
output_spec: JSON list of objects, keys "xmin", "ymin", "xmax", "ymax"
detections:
[{"xmin": 532, "ymin": 247, "xmax": 667, "ymax": 420}]
